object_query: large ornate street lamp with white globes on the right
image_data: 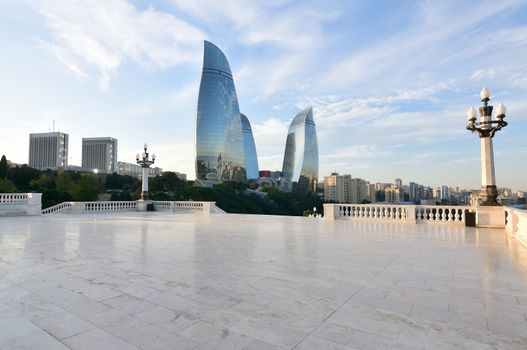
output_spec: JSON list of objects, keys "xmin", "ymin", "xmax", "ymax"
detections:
[{"xmin": 467, "ymin": 87, "xmax": 507, "ymax": 206}]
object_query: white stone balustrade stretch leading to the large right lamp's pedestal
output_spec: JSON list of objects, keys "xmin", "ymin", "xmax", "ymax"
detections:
[{"xmin": 324, "ymin": 203, "xmax": 474, "ymax": 224}]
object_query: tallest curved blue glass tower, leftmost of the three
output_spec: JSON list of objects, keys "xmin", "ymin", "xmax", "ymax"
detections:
[{"xmin": 196, "ymin": 41, "xmax": 247, "ymax": 181}]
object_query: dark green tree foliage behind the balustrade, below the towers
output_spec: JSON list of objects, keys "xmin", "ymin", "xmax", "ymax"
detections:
[{"xmin": 5, "ymin": 165, "xmax": 323, "ymax": 215}]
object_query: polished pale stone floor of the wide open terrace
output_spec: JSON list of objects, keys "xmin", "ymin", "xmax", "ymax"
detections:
[{"xmin": 0, "ymin": 213, "xmax": 527, "ymax": 350}]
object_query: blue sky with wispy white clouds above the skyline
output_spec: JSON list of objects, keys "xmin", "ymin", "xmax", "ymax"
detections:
[{"xmin": 0, "ymin": 0, "xmax": 527, "ymax": 190}]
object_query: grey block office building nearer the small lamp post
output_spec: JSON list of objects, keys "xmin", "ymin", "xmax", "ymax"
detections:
[{"xmin": 82, "ymin": 137, "xmax": 117, "ymax": 174}]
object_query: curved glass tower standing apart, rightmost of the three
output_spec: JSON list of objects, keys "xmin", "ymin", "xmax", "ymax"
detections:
[{"xmin": 282, "ymin": 107, "xmax": 318, "ymax": 193}]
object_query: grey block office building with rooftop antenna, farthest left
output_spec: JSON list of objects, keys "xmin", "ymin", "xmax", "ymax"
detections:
[{"xmin": 28, "ymin": 132, "xmax": 68, "ymax": 170}]
